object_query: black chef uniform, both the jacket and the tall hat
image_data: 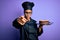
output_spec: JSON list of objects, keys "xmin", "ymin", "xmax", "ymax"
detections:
[{"xmin": 13, "ymin": 2, "xmax": 43, "ymax": 40}]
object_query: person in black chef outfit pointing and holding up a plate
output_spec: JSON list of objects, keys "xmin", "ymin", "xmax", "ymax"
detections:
[{"xmin": 13, "ymin": 2, "xmax": 48, "ymax": 40}]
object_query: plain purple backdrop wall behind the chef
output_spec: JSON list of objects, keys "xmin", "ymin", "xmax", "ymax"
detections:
[{"xmin": 0, "ymin": 0, "xmax": 60, "ymax": 40}]
